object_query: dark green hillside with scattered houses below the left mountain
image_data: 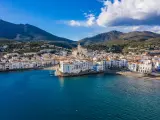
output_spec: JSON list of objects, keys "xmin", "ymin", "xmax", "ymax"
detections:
[{"xmin": 0, "ymin": 39, "xmax": 72, "ymax": 54}]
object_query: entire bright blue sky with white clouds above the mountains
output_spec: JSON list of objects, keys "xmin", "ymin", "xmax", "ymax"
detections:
[{"xmin": 0, "ymin": 0, "xmax": 160, "ymax": 41}]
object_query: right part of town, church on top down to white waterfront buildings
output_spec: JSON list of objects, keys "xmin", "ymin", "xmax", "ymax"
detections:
[{"xmin": 57, "ymin": 45, "xmax": 160, "ymax": 74}]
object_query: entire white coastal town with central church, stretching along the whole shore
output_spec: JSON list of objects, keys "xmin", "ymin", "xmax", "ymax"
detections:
[{"xmin": 0, "ymin": 44, "xmax": 160, "ymax": 77}]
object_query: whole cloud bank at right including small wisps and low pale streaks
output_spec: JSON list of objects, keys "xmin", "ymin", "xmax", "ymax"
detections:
[{"xmin": 64, "ymin": 0, "xmax": 160, "ymax": 36}]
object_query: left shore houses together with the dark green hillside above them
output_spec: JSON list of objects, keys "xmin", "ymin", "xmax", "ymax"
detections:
[{"xmin": 0, "ymin": 42, "xmax": 68, "ymax": 72}]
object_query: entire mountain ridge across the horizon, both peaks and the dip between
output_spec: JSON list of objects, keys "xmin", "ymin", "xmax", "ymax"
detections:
[{"xmin": 0, "ymin": 20, "xmax": 160, "ymax": 48}]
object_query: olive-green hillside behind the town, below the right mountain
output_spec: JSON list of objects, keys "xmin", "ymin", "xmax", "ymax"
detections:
[{"xmin": 86, "ymin": 38, "xmax": 160, "ymax": 54}]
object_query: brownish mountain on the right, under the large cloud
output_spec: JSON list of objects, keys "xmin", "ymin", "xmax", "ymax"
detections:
[{"xmin": 79, "ymin": 31, "xmax": 160, "ymax": 45}]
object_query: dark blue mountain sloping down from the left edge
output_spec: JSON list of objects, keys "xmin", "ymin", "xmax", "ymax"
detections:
[{"xmin": 0, "ymin": 20, "xmax": 74, "ymax": 43}]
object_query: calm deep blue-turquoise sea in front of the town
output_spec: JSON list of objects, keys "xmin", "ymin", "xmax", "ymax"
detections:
[{"xmin": 0, "ymin": 70, "xmax": 160, "ymax": 120}]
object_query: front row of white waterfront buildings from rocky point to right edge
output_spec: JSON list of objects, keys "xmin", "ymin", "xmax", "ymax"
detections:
[{"xmin": 59, "ymin": 59, "xmax": 160, "ymax": 74}]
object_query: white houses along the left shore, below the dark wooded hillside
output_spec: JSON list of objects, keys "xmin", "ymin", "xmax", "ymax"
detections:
[{"xmin": 0, "ymin": 53, "xmax": 58, "ymax": 71}]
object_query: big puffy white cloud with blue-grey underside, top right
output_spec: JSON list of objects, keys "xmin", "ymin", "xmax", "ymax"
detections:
[{"xmin": 97, "ymin": 0, "xmax": 160, "ymax": 26}]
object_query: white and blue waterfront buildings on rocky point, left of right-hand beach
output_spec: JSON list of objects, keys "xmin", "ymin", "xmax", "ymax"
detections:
[{"xmin": 59, "ymin": 59, "xmax": 127, "ymax": 74}]
